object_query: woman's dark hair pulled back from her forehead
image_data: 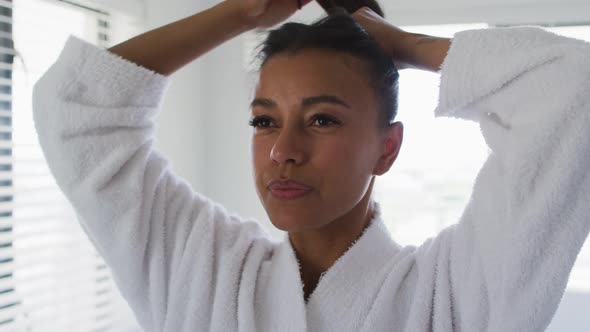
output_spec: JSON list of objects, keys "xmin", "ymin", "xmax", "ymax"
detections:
[{"xmin": 258, "ymin": 10, "xmax": 399, "ymax": 126}]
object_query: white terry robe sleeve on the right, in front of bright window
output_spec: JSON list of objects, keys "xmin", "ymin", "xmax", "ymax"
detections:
[{"xmin": 431, "ymin": 27, "xmax": 590, "ymax": 331}]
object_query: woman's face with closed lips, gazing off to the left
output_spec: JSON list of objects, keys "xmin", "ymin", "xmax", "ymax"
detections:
[{"xmin": 252, "ymin": 50, "xmax": 401, "ymax": 232}]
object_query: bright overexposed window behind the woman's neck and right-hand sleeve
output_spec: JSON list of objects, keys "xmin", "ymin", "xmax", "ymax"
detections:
[{"xmin": 375, "ymin": 24, "xmax": 590, "ymax": 292}]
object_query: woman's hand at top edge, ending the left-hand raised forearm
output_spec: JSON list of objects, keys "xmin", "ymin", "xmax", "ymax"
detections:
[{"xmin": 226, "ymin": 0, "xmax": 311, "ymax": 29}]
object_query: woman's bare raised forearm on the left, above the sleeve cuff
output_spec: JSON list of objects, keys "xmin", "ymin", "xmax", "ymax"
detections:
[{"xmin": 109, "ymin": 0, "xmax": 297, "ymax": 76}]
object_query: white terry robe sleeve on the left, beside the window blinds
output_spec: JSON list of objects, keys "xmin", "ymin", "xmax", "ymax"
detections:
[{"xmin": 33, "ymin": 36, "xmax": 263, "ymax": 331}]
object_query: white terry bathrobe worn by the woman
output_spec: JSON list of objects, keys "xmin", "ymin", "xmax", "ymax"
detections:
[{"xmin": 33, "ymin": 27, "xmax": 590, "ymax": 332}]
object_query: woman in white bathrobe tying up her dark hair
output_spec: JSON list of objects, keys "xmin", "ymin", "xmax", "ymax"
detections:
[{"xmin": 33, "ymin": 0, "xmax": 590, "ymax": 332}]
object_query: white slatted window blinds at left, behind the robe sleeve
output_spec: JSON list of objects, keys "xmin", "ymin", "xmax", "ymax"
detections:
[{"xmin": 7, "ymin": 0, "xmax": 140, "ymax": 332}]
